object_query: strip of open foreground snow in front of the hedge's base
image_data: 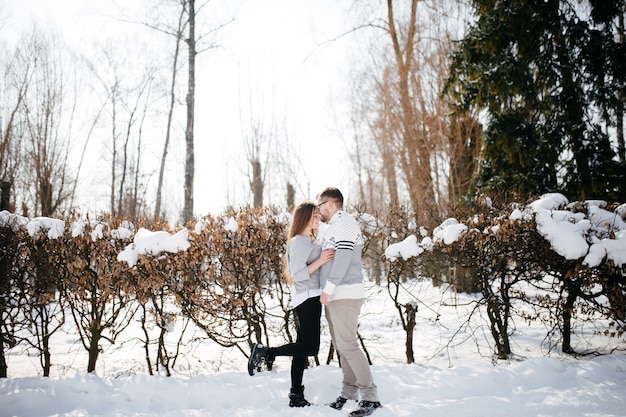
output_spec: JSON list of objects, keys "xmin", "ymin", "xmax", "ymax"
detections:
[{"xmin": 0, "ymin": 356, "xmax": 626, "ymax": 417}]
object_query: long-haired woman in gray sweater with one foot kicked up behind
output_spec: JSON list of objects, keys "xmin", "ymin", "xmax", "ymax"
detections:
[{"xmin": 248, "ymin": 201, "xmax": 335, "ymax": 407}]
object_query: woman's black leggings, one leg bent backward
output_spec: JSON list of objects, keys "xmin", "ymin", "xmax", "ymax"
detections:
[{"xmin": 267, "ymin": 297, "xmax": 322, "ymax": 391}]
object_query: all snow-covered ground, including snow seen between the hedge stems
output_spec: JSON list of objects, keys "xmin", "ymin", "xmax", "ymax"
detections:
[{"xmin": 0, "ymin": 281, "xmax": 626, "ymax": 417}]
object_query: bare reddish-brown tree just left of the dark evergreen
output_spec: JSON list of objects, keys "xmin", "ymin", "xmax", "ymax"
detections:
[{"xmin": 352, "ymin": 0, "xmax": 468, "ymax": 227}]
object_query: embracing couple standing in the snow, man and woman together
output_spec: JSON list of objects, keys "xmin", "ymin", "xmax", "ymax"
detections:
[{"xmin": 248, "ymin": 188, "xmax": 381, "ymax": 417}]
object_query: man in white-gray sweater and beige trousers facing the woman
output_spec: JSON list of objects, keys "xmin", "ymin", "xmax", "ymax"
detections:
[{"xmin": 317, "ymin": 187, "xmax": 381, "ymax": 417}]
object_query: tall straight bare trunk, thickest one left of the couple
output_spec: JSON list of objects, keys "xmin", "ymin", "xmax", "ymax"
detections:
[{"xmin": 183, "ymin": 0, "xmax": 197, "ymax": 223}]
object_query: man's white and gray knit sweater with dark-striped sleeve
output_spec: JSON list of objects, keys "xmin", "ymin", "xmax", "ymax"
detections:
[{"xmin": 320, "ymin": 210, "xmax": 365, "ymax": 301}]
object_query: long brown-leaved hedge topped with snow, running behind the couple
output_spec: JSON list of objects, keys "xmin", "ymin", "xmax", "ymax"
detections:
[{"xmin": 0, "ymin": 194, "xmax": 626, "ymax": 376}]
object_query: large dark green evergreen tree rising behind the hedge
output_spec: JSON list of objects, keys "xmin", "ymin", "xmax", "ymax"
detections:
[{"xmin": 448, "ymin": 0, "xmax": 624, "ymax": 199}]
